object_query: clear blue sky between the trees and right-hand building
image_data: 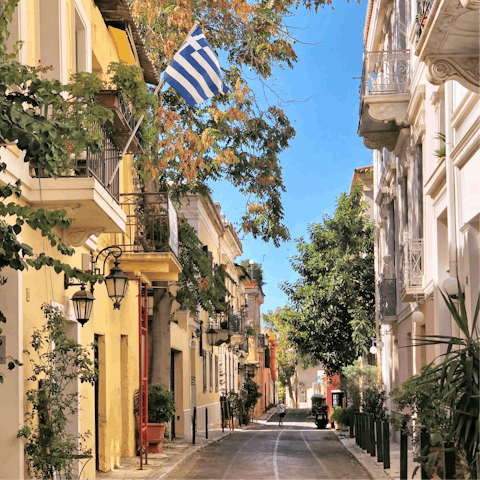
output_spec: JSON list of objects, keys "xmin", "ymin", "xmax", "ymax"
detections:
[{"xmin": 208, "ymin": 0, "xmax": 372, "ymax": 313}]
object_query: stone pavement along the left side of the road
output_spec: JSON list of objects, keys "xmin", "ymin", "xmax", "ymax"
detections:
[{"xmin": 97, "ymin": 408, "xmax": 275, "ymax": 480}]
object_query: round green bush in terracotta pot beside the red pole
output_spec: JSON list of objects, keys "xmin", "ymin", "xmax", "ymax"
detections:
[{"xmin": 134, "ymin": 383, "xmax": 175, "ymax": 453}]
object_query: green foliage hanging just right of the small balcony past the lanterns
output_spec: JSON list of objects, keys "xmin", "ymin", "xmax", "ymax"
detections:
[{"xmin": 174, "ymin": 222, "xmax": 228, "ymax": 317}]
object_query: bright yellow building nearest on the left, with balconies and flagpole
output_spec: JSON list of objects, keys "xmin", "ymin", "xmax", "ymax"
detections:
[{"xmin": 0, "ymin": 0, "xmax": 180, "ymax": 479}]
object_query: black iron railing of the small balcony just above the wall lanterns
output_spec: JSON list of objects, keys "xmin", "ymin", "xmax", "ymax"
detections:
[{"xmin": 120, "ymin": 192, "xmax": 178, "ymax": 257}]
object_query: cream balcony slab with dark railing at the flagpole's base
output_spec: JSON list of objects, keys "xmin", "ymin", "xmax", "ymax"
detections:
[{"xmin": 31, "ymin": 129, "xmax": 126, "ymax": 247}]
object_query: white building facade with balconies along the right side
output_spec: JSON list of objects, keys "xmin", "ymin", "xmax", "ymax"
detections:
[{"xmin": 359, "ymin": 0, "xmax": 480, "ymax": 409}]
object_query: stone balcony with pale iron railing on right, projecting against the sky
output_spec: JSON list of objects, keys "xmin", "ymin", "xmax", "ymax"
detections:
[{"xmin": 358, "ymin": 50, "xmax": 410, "ymax": 151}]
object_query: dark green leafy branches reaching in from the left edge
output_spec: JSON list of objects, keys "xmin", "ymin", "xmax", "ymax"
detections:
[{"xmin": 0, "ymin": 0, "xmax": 102, "ymax": 383}]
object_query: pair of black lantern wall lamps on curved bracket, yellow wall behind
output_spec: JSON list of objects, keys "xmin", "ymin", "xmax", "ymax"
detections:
[{"xmin": 64, "ymin": 245, "xmax": 129, "ymax": 326}]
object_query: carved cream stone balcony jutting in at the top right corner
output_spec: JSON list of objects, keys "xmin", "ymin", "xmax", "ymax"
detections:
[{"xmin": 415, "ymin": 0, "xmax": 480, "ymax": 93}]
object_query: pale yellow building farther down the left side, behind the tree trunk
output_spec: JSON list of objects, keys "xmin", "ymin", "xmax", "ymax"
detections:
[{"xmin": 171, "ymin": 196, "xmax": 250, "ymax": 438}]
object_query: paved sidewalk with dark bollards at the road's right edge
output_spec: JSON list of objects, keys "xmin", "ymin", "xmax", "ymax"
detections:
[{"xmin": 335, "ymin": 430, "xmax": 421, "ymax": 480}]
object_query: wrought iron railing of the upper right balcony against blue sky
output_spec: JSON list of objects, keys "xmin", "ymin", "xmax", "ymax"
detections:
[{"xmin": 360, "ymin": 50, "xmax": 410, "ymax": 98}]
